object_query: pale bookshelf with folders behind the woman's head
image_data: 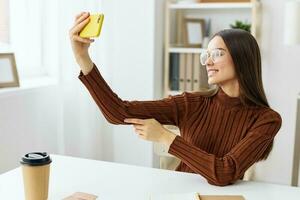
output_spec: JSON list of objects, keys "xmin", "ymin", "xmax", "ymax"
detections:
[{"xmin": 163, "ymin": 0, "xmax": 261, "ymax": 96}]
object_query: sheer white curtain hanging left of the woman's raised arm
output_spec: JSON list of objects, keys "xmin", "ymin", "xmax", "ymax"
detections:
[{"xmin": 57, "ymin": 0, "xmax": 104, "ymax": 159}]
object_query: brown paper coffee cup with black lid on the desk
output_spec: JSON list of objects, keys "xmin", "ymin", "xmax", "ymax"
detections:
[{"xmin": 20, "ymin": 152, "xmax": 52, "ymax": 200}]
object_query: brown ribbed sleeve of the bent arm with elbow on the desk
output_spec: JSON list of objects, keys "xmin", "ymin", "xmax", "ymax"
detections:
[{"xmin": 169, "ymin": 111, "xmax": 281, "ymax": 186}]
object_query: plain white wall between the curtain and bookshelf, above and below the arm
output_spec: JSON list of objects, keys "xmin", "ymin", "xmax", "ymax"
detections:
[{"xmin": 98, "ymin": 0, "xmax": 161, "ymax": 166}]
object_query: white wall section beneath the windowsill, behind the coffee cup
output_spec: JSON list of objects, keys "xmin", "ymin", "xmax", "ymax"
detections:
[{"xmin": 0, "ymin": 86, "xmax": 60, "ymax": 173}]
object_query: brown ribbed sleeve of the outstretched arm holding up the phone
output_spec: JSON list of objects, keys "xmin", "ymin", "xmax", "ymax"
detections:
[{"xmin": 78, "ymin": 65, "xmax": 186, "ymax": 126}]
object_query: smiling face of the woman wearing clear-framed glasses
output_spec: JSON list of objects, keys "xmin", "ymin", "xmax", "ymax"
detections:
[{"xmin": 204, "ymin": 36, "xmax": 237, "ymax": 86}]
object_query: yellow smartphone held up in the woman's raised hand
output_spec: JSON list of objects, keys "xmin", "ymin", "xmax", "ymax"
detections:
[{"xmin": 79, "ymin": 14, "xmax": 104, "ymax": 38}]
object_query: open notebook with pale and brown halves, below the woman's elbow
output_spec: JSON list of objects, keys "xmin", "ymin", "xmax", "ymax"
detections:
[{"xmin": 150, "ymin": 192, "xmax": 245, "ymax": 200}]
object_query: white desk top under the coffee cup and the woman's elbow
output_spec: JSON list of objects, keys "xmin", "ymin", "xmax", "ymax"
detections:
[{"xmin": 0, "ymin": 155, "xmax": 300, "ymax": 200}]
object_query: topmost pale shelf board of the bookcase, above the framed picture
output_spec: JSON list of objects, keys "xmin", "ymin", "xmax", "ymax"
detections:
[{"xmin": 169, "ymin": 3, "xmax": 253, "ymax": 9}]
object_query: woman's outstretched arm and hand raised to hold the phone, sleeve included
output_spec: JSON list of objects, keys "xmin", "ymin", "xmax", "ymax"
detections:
[{"xmin": 69, "ymin": 12, "xmax": 185, "ymax": 126}]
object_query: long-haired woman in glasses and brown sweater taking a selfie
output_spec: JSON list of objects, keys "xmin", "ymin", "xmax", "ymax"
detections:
[{"xmin": 70, "ymin": 13, "xmax": 281, "ymax": 186}]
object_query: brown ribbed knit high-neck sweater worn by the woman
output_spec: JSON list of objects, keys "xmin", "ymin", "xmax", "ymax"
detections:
[{"xmin": 79, "ymin": 66, "xmax": 281, "ymax": 185}]
